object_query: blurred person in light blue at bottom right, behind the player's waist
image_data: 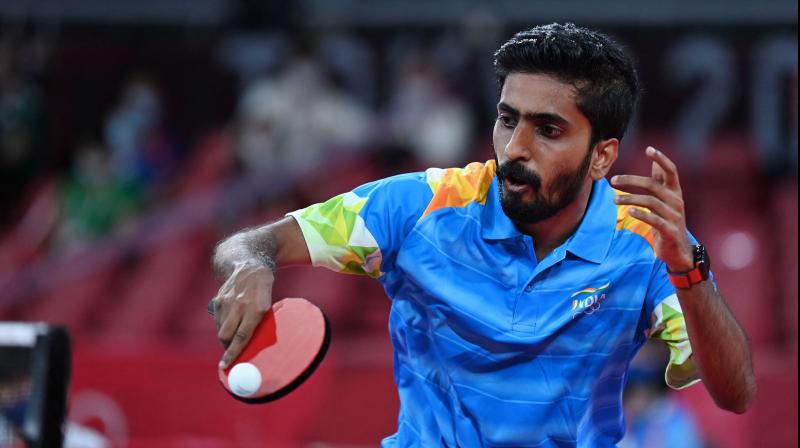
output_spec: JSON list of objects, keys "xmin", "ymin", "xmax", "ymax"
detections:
[{"xmin": 618, "ymin": 343, "xmax": 704, "ymax": 448}]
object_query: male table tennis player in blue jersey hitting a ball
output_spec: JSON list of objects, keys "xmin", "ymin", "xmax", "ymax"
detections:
[{"xmin": 214, "ymin": 24, "xmax": 756, "ymax": 447}]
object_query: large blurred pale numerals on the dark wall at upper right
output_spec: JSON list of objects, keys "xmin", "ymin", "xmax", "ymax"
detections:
[{"xmin": 664, "ymin": 34, "xmax": 798, "ymax": 170}]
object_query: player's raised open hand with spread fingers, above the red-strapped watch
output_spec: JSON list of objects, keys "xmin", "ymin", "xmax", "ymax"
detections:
[{"xmin": 611, "ymin": 146, "xmax": 694, "ymax": 272}]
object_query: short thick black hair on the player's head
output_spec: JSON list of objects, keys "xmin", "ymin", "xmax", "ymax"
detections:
[{"xmin": 494, "ymin": 23, "xmax": 640, "ymax": 146}]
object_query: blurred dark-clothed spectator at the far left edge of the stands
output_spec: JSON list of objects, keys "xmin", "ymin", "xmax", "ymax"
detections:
[{"xmin": 0, "ymin": 36, "xmax": 44, "ymax": 228}]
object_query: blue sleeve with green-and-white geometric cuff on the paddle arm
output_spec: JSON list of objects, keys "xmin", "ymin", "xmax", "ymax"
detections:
[{"xmin": 287, "ymin": 173, "xmax": 432, "ymax": 278}]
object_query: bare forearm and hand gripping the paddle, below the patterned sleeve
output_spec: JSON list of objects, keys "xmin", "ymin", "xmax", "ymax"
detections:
[{"xmin": 212, "ymin": 216, "xmax": 311, "ymax": 368}]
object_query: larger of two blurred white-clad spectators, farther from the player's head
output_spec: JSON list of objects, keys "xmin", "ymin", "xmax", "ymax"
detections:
[{"xmin": 235, "ymin": 53, "xmax": 372, "ymax": 173}]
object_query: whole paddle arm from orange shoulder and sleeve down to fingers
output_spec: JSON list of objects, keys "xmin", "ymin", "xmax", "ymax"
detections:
[{"xmin": 213, "ymin": 163, "xmax": 446, "ymax": 368}]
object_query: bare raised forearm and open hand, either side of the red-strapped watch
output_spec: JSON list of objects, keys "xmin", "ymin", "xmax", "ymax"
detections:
[{"xmin": 611, "ymin": 147, "xmax": 757, "ymax": 413}]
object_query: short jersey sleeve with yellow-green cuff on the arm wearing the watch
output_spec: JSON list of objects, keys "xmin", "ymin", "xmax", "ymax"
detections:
[{"xmin": 646, "ymin": 234, "xmax": 713, "ymax": 389}]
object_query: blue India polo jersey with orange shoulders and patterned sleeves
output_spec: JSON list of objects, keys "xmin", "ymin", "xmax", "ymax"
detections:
[{"xmin": 290, "ymin": 161, "xmax": 698, "ymax": 447}]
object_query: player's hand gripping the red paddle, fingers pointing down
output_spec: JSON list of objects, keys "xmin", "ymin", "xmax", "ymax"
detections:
[{"xmin": 213, "ymin": 261, "xmax": 275, "ymax": 369}]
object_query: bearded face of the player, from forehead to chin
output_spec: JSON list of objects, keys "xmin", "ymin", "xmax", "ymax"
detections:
[{"xmin": 493, "ymin": 73, "xmax": 592, "ymax": 228}]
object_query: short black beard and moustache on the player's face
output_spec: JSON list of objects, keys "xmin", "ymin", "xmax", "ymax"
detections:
[{"xmin": 495, "ymin": 147, "xmax": 592, "ymax": 224}]
